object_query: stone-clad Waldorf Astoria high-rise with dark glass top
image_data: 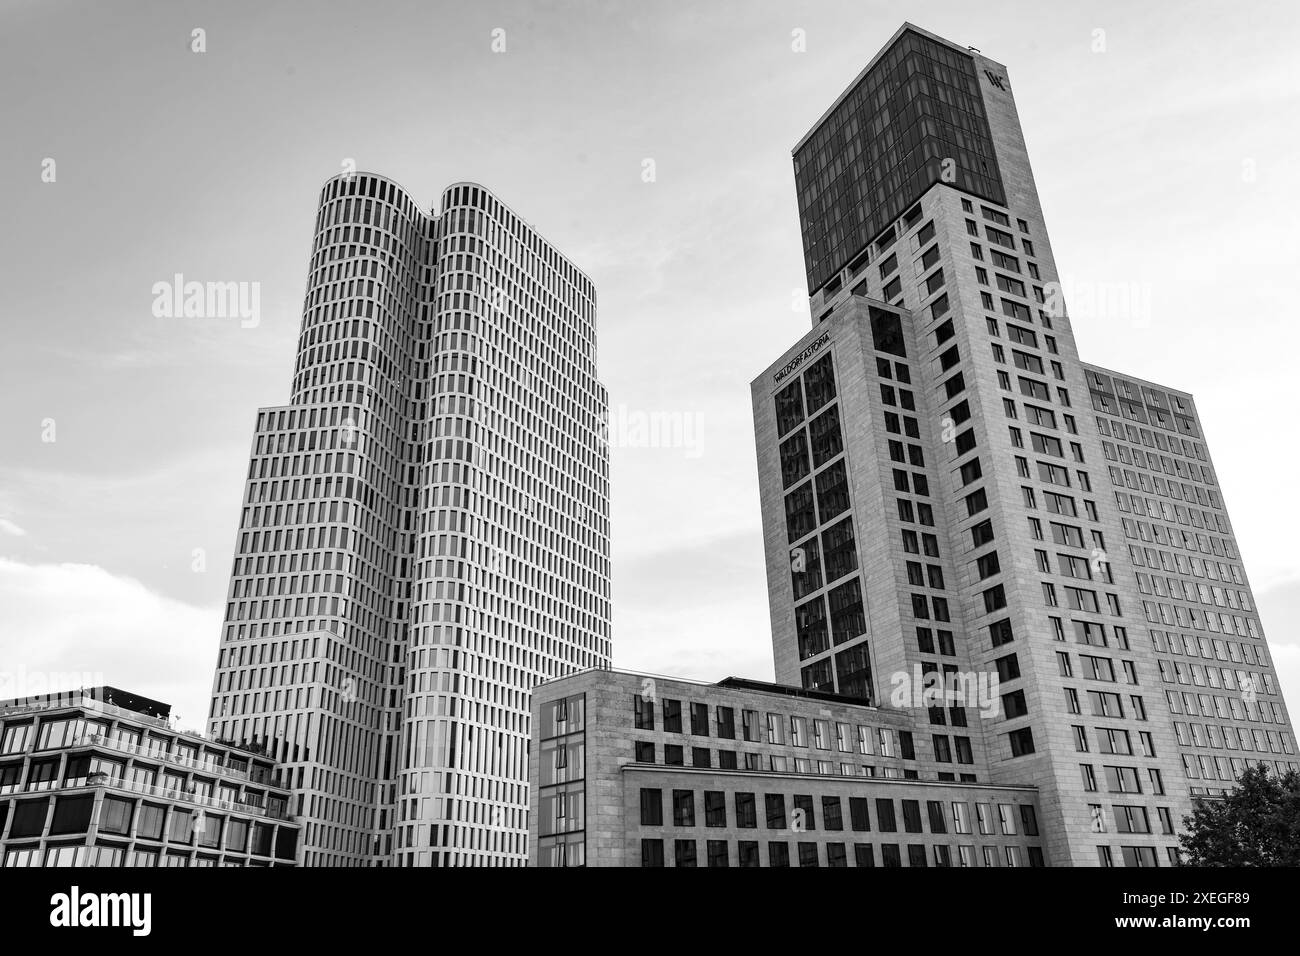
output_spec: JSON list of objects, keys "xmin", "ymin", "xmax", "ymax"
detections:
[{"xmin": 751, "ymin": 25, "xmax": 1296, "ymax": 866}]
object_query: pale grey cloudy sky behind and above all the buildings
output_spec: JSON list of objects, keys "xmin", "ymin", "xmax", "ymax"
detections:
[{"xmin": 0, "ymin": 0, "xmax": 1300, "ymax": 727}]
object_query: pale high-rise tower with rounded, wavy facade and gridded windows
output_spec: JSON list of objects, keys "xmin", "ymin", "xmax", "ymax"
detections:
[{"xmin": 209, "ymin": 173, "xmax": 610, "ymax": 866}]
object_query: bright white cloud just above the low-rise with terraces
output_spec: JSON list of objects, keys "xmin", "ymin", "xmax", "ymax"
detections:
[{"xmin": 0, "ymin": 558, "xmax": 221, "ymax": 728}]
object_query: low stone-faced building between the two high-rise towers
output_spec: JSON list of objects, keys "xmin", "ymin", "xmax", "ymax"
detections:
[{"xmin": 529, "ymin": 670, "xmax": 1047, "ymax": 866}]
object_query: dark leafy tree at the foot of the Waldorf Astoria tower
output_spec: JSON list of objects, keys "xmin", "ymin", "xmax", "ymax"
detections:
[{"xmin": 1178, "ymin": 763, "xmax": 1300, "ymax": 866}]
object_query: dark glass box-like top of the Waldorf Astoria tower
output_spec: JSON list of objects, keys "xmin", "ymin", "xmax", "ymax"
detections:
[{"xmin": 794, "ymin": 25, "xmax": 1006, "ymax": 294}]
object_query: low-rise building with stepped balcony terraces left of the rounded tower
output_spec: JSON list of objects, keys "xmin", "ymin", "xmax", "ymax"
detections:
[{"xmin": 0, "ymin": 687, "xmax": 300, "ymax": 866}]
